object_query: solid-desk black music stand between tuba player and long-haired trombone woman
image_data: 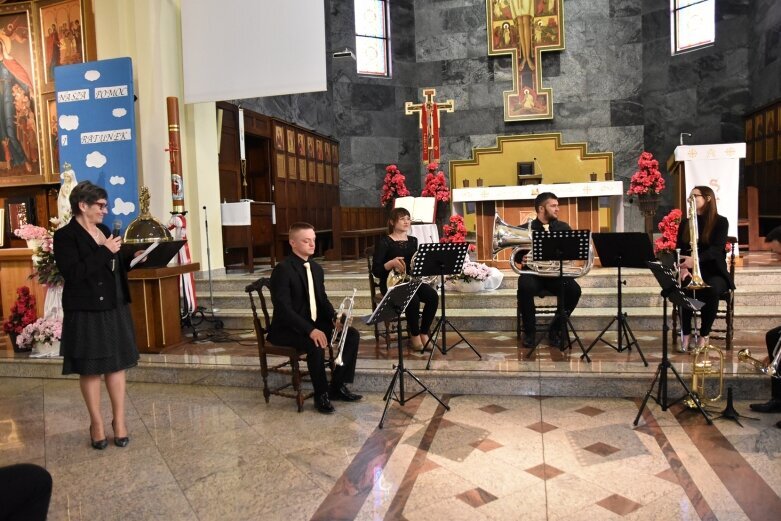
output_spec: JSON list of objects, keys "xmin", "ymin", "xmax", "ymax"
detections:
[{"xmin": 586, "ymin": 232, "xmax": 654, "ymax": 367}]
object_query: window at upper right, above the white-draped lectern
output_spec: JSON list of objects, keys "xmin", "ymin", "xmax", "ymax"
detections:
[{"xmin": 671, "ymin": 0, "xmax": 716, "ymax": 54}]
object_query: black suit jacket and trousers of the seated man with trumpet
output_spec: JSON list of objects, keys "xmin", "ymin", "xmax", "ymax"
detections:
[{"xmin": 267, "ymin": 254, "xmax": 360, "ymax": 395}]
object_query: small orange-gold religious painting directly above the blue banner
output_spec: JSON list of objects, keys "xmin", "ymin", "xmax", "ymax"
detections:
[{"xmin": 38, "ymin": 0, "xmax": 85, "ymax": 88}]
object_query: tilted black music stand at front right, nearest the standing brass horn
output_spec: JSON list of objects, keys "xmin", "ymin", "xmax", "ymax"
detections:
[{"xmin": 634, "ymin": 262, "xmax": 713, "ymax": 425}]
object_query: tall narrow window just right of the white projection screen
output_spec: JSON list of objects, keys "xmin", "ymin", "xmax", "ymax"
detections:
[{"xmin": 355, "ymin": 0, "xmax": 390, "ymax": 77}]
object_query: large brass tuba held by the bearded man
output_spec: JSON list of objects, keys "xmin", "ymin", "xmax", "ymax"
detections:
[{"xmin": 491, "ymin": 214, "xmax": 594, "ymax": 278}]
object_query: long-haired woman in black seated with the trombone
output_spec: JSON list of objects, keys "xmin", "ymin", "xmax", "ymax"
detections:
[{"xmin": 677, "ymin": 186, "xmax": 735, "ymax": 352}]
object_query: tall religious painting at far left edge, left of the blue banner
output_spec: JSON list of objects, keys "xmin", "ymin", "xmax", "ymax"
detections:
[{"xmin": 0, "ymin": 6, "xmax": 41, "ymax": 184}]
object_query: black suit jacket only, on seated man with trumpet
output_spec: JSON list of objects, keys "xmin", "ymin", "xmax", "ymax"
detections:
[{"xmin": 268, "ymin": 254, "xmax": 336, "ymax": 344}]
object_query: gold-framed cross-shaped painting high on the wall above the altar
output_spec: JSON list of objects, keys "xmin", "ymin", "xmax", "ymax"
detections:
[{"xmin": 486, "ymin": 0, "xmax": 564, "ymax": 121}]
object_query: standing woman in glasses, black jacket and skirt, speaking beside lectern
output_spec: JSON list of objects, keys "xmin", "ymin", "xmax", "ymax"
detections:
[{"xmin": 54, "ymin": 181, "xmax": 141, "ymax": 450}]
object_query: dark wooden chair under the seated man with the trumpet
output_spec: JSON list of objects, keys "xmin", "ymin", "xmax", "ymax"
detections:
[{"xmin": 244, "ymin": 277, "xmax": 314, "ymax": 412}]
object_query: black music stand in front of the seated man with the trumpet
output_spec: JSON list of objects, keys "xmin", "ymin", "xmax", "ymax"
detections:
[{"xmin": 365, "ymin": 279, "xmax": 450, "ymax": 429}]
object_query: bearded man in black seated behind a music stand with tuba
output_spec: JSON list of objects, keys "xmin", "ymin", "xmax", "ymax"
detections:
[{"xmin": 511, "ymin": 192, "xmax": 581, "ymax": 349}]
